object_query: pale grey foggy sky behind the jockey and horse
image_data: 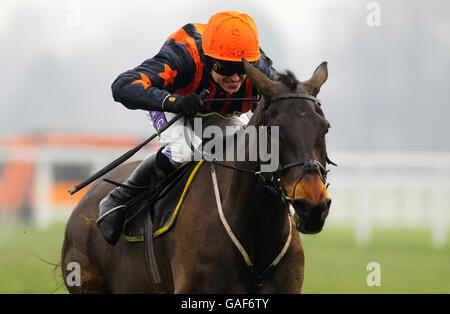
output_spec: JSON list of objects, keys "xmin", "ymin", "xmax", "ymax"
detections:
[{"xmin": 0, "ymin": 0, "xmax": 450, "ymax": 151}]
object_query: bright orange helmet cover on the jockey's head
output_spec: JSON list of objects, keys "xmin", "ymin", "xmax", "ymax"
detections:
[{"xmin": 202, "ymin": 11, "xmax": 261, "ymax": 62}]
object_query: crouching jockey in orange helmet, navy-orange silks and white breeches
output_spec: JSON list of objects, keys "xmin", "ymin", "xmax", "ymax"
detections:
[{"xmin": 97, "ymin": 11, "xmax": 278, "ymax": 245}]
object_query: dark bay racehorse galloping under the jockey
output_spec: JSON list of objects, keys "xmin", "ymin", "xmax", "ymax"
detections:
[{"xmin": 61, "ymin": 60, "xmax": 331, "ymax": 293}]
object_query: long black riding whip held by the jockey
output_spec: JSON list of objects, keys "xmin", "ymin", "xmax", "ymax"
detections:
[{"xmin": 68, "ymin": 89, "xmax": 209, "ymax": 195}]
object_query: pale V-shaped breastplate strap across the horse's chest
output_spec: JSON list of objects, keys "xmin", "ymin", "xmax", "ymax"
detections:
[{"xmin": 211, "ymin": 164, "xmax": 292, "ymax": 287}]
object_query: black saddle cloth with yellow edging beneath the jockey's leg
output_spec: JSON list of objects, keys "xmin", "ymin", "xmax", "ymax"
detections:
[{"xmin": 123, "ymin": 159, "xmax": 204, "ymax": 242}]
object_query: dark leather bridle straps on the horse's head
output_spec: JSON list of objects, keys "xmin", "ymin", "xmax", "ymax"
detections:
[{"xmin": 204, "ymin": 93, "xmax": 336, "ymax": 202}]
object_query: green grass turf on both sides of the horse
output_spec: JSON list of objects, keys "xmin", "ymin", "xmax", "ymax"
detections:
[{"xmin": 0, "ymin": 224, "xmax": 450, "ymax": 293}]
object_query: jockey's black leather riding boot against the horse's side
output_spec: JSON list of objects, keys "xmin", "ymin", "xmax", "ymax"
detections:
[{"xmin": 97, "ymin": 151, "xmax": 175, "ymax": 245}]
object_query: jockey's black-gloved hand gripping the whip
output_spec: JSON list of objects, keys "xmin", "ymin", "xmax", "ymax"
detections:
[{"xmin": 162, "ymin": 93, "xmax": 211, "ymax": 116}]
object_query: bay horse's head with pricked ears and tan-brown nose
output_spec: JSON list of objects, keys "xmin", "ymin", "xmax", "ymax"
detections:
[{"xmin": 244, "ymin": 60, "xmax": 331, "ymax": 233}]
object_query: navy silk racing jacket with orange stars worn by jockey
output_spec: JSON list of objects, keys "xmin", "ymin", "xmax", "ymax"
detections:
[{"xmin": 112, "ymin": 24, "xmax": 277, "ymax": 114}]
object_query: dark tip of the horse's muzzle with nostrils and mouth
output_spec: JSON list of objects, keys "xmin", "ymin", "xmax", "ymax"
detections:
[{"xmin": 292, "ymin": 199, "xmax": 331, "ymax": 234}]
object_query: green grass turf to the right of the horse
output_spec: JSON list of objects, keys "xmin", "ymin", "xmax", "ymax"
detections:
[{"xmin": 302, "ymin": 229, "xmax": 450, "ymax": 293}]
